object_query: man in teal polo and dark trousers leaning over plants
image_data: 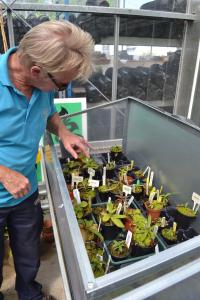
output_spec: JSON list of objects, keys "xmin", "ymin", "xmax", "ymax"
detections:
[{"xmin": 0, "ymin": 21, "xmax": 93, "ymax": 300}]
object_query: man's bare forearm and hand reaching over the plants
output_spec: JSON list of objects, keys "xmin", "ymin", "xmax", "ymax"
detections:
[{"xmin": 47, "ymin": 113, "xmax": 91, "ymax": 158}]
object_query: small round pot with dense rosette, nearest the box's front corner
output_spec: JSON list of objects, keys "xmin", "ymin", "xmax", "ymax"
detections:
[{"xmin": 108, "ymin": 240, "xmax": 131, "ymax": 261}]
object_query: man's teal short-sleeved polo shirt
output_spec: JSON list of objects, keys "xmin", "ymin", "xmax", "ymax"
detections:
[{"xmin": 0, "ymin": 48, "xmax": 56, "ymax": 207}]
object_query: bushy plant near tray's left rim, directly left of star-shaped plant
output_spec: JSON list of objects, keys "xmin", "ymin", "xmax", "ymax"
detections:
[{"xmin": 78, "ymin": 219, "xmax": 103, "ymax": 242}]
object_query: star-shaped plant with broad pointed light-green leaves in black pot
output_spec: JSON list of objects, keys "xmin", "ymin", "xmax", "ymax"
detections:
[{"xmin": 101, "ymin": 202, "xmax": 126, "ymax": 240}]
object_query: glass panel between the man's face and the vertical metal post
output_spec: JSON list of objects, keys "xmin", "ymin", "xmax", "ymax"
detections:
[{"xmin": 72, "ymin": 13, "xmax": 114, "ymax": 107}]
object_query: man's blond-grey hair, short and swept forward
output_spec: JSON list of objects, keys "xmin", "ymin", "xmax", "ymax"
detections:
[{"xmin": 17, "ymin": 21, "xmax": 94, "ymax": 80}]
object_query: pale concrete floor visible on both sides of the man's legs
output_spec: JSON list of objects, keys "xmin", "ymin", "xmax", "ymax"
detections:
[{"xmin": 1, "ymin": 241, "xmax": 66, "ymax": 300}]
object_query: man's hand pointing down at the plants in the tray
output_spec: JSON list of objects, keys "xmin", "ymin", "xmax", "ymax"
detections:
[{"xmin": 62, "ymin": 131, "xmax": 92, "ymax": 158}]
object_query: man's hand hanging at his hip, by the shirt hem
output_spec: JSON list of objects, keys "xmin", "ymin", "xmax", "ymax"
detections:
[{"xmin": 0, "ymin": 166, "xmax": 31, "ymax": 199}]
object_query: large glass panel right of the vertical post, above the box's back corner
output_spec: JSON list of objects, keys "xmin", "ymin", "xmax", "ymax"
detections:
[{"xmin": 117, "ymin": 18, "xmax": 184, "ymax": 112}]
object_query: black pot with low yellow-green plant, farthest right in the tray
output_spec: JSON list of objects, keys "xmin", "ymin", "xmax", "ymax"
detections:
[{"xmin": 176, "ymin": 203, "xmax": 197, "ymax": 229}]
